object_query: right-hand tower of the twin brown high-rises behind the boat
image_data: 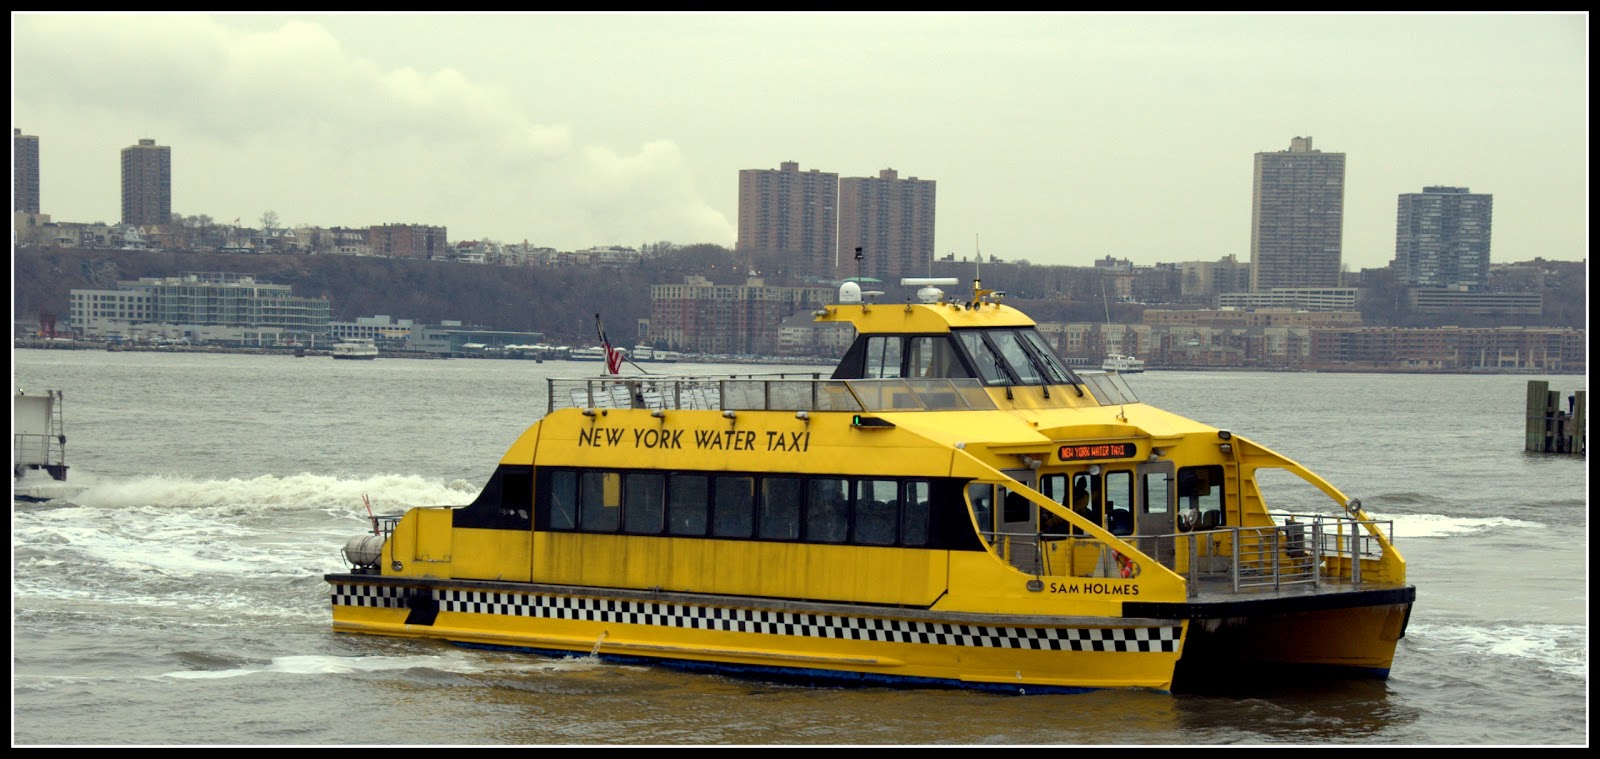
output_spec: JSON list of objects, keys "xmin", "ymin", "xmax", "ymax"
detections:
[{"xmin": 837, "ymin": 168, "xmax": 936, "ymax": 283}]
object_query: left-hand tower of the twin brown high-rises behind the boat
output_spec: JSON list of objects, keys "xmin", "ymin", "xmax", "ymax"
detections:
[{"xmin": 734, "ymin": 160, "xmax": 838, "ymax": 280}]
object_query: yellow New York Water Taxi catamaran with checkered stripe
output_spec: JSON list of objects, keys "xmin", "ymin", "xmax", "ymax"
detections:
[{"xmin": 326, "ymin": 280, "xmax": 1416, "ymax": 693}]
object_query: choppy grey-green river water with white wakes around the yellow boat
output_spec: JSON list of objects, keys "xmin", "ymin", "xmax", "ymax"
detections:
[{"xmin": 11, "ymin": 351, "xmax": 1589, "ymax": 746}]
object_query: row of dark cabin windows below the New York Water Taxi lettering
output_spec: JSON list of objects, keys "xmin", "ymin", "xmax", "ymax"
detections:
[{"xmin": 542, "ymin": 469, "xmax": 931, "ymax": 546}]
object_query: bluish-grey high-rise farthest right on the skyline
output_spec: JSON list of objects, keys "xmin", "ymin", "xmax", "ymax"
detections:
[{"xmin": 1395, "ymin": 187, "xmax": 1494, "ymax": 291}]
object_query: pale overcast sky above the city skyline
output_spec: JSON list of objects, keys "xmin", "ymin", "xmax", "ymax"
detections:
[{"xmin": 11, "ymin": 13, "xmax": 1589, "ymax": 269}]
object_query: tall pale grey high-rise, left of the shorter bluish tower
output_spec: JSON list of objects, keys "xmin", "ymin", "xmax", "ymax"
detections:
[{"xmin": 1250, "ymin": 138, "xmax": 1344, "ymax": 291}]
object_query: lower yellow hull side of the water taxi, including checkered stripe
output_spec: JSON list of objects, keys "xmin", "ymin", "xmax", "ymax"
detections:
[{"xmin": 328, "ymin": 575, "xmax": 1184, "ymax": 693}]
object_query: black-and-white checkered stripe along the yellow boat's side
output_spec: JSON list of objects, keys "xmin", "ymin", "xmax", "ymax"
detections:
[{"xmin": 333, "ymin": 584, "xmax": 1182, "ymax": 653}]
